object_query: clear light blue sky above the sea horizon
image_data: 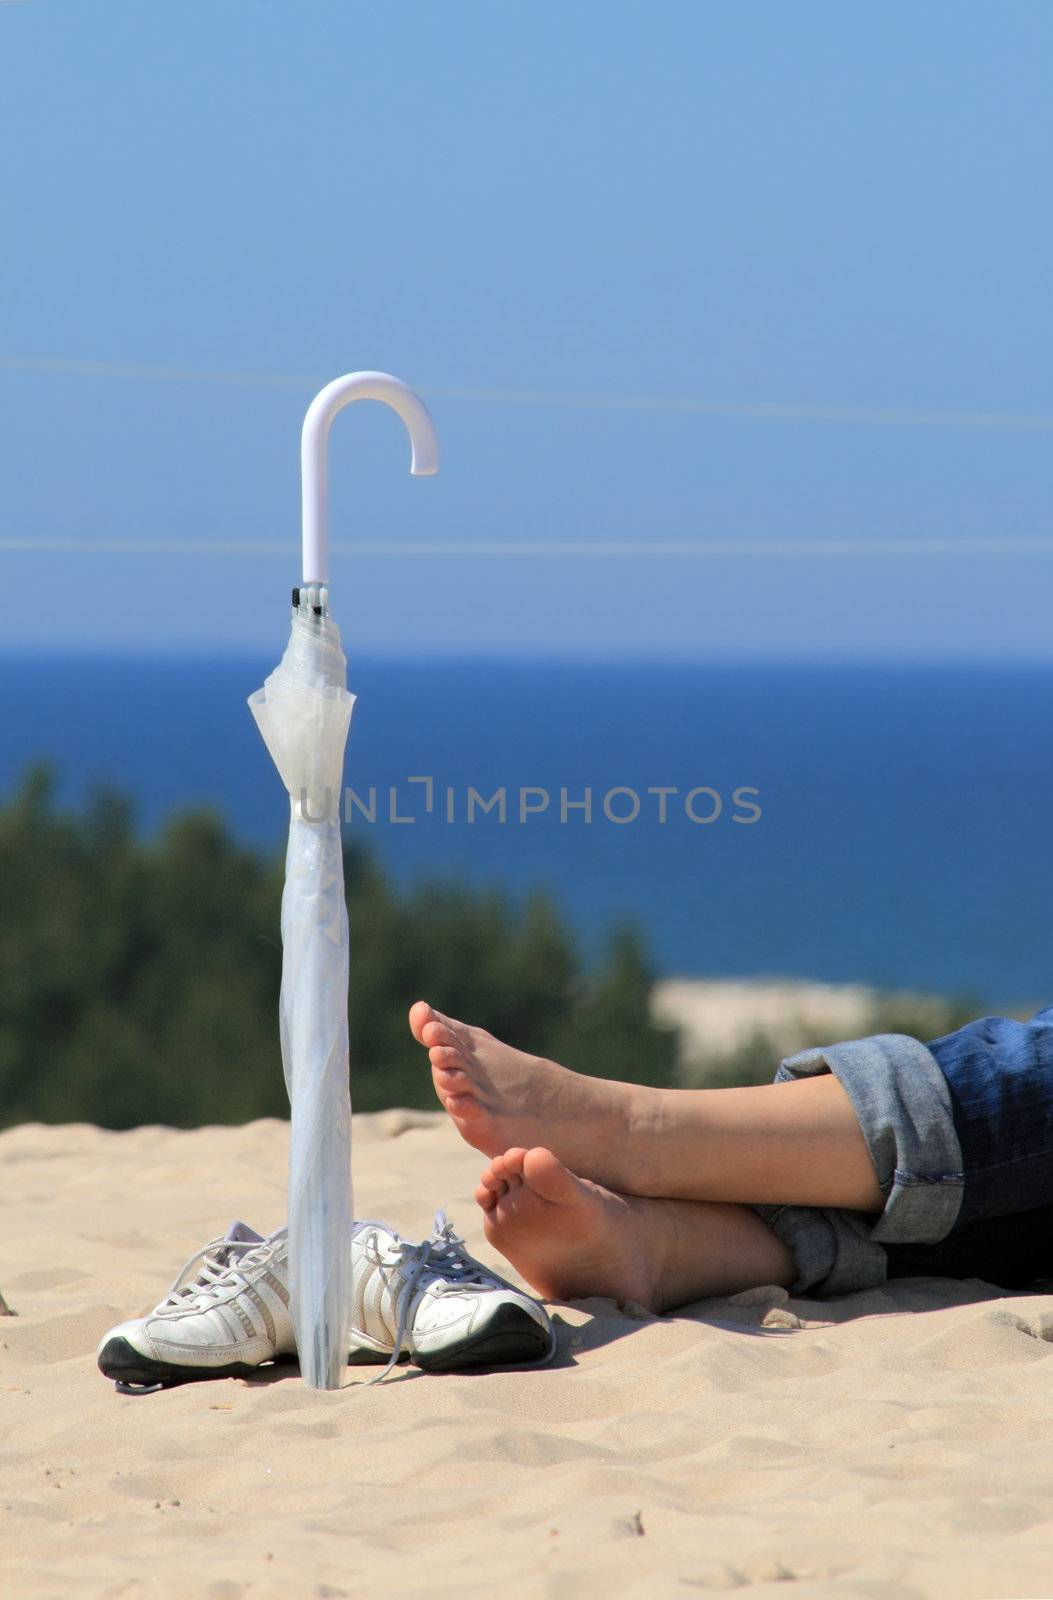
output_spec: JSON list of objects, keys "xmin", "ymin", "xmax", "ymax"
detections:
[{"xmin": 0, "ymin": 0, "xmax": 1053, "ymax": 656}]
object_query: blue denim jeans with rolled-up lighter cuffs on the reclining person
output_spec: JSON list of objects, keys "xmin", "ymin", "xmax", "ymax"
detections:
[{"xmin": 754, "ymin": 1006, "xmax": 1053, "ymax": 1296}]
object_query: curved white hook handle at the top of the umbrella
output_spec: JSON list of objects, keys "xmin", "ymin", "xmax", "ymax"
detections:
[{"xmin": 299, "ymin": 373, "xmax": 438, "ymax": 584}]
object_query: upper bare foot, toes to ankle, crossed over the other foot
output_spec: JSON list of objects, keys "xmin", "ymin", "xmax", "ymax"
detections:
[{"xmin": 410, "ymin": 1000, "xmax": 658, "ymax": 1190}]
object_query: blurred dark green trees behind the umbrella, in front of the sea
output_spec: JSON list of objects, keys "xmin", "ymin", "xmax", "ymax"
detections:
[{"xmin": 0, "ymin": 768, "xmax": 677, "ymax": 1128}]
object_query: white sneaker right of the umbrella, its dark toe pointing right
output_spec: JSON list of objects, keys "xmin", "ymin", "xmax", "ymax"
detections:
[{"xmin": 350, "ymin": 1211, "xmax": 555, "ymax": 1373}]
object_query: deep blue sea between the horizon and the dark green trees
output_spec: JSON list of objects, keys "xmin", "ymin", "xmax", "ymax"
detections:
[{"xmin": 0, "ymin": 658, "xmax": 1053, "ymax": 1003}]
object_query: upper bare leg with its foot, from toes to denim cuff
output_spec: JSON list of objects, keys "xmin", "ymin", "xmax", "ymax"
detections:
[{"xmin": 410, "ymin": 1000, "xmax": 885, "ymax": 1211}]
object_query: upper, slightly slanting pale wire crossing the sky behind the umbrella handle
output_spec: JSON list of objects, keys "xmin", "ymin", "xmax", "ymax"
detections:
[{"xmin": 0, "ymin": 355, "xmax": 1053, "ymax": 434}]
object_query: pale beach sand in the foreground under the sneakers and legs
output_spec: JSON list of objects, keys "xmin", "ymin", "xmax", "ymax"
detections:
[{"xmin": 0, "ymin": 1112, "xmax": 1053, "ymax": 1600}]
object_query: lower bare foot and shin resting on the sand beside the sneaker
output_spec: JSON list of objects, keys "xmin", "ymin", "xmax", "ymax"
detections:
[{"xmin": 475, "ymin": 1149, "xmax": 795, "ymax": 1312}]
